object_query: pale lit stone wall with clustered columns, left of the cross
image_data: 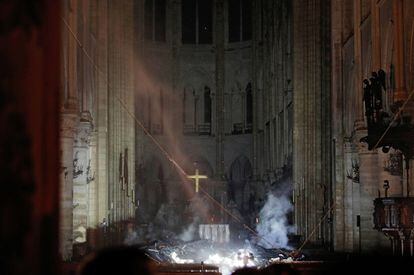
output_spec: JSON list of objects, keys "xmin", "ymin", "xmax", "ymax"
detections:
[{"xmin": 60, "ymin": 0, "xmax": 135, "ymax": 260}]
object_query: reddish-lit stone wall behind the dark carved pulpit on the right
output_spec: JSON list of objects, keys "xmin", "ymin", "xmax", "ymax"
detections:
[{"xmin": 331, "ymin": 0, "xmax": 414, "ymax": 252}]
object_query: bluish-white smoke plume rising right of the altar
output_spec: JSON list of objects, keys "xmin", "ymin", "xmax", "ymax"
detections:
[{"xmin": 256, "ymin": 184, "xmax": 294, "ymax": 248}]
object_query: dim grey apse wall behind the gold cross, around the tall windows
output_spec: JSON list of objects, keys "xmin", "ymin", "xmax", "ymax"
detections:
[{"xmin": 135, "ymin": 0, "xmax": 293, "ymax": 237}]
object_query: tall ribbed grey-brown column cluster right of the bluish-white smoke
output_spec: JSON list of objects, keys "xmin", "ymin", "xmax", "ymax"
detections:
[{"xmin": 293, "ymin": 0, "xmax": 331, "ymax": 244}]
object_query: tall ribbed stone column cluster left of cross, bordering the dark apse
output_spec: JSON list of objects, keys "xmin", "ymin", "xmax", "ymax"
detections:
[{"xmin": 105, "ymin": 0, "xmax": 135, "ymax": 227}]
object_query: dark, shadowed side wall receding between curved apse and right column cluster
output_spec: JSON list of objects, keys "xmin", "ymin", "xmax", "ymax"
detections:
[{"xmin": 252, "ymin": 1, "xmax": 294, "ymax": 183}]
